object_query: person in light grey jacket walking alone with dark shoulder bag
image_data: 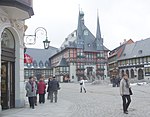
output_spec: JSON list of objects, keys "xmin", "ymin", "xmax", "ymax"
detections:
[{"xmin": 120, "ymin": 74, "xmax": 131, "ymax": 114}]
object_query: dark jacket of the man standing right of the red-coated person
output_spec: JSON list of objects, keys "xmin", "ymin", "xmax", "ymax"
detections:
[{"xmin": 48, "ymin": 79, "xmax": 59, "ymax": 92}]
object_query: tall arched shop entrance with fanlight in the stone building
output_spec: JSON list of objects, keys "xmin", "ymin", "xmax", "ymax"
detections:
[{"xmin": 0, "ymin": 29, "xmax": 15, "ymax": 110}]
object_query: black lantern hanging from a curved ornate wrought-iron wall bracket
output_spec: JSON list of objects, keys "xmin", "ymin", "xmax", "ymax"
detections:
[{"xmin": 24, "ymin": 27, "xmax": 50, "ymax": 49}]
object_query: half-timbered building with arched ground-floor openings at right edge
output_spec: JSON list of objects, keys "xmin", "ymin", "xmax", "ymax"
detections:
[{"xmin": 118, "ymin": 38, "xmax": 150, "ymax": 80}]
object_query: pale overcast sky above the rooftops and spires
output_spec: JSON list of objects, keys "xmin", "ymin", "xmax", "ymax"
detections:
[{"xmin": 26, "ymin": 0, "xmax": 150, "ymax": 50}]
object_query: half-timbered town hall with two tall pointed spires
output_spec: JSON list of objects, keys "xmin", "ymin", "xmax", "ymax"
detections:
[{"xmin": 49, "ymin": 11, "xmax": 109, "ymax": 82}]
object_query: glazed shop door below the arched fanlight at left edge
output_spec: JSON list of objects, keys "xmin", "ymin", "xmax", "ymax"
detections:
[{"xmin": 1, "ymin": 61, "xmax": 15, "ymax": 109}]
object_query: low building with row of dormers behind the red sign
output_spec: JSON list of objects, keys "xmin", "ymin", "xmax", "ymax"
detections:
[{"xmin": 24, "ymin": 46, "xmax": 58, "ymax": 80}]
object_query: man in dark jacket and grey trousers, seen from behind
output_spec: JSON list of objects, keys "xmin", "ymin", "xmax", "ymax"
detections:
[{"xmin": 48, "ymin": 76, "xmax": 60, "ymax": 103}]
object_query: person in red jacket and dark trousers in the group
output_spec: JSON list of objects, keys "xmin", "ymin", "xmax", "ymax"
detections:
[{"xmin": 38, "ymin": 78, "xmax": 46, "ymax": 103}]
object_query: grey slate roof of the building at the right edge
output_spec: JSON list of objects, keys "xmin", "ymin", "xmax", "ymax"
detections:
[{"xmin": 118, "ymin": 38, "xmax": 150, "ymax": 60}]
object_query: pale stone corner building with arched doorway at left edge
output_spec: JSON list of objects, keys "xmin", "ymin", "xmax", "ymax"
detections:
[{"xmin": 0, "ymin": 0, "xmax": 34, "ymax": 110}]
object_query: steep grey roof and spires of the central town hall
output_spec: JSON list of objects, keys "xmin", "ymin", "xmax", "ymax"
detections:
[{"xmin": 59, "ymin": 11, "xmax": 109, "ymax": 52}]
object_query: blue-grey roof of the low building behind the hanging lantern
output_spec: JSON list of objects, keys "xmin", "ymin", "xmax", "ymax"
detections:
[{"xmin": 26, "ymin": 46, "xmax": 58, "ymax": 67}]
